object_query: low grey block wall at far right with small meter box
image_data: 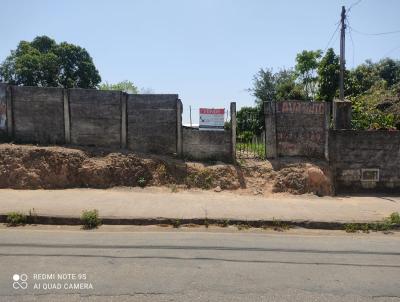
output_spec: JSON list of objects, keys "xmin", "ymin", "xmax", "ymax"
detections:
[{"xmin": 329, "ymin": 130, "xmax": 400, "ymax": 193}]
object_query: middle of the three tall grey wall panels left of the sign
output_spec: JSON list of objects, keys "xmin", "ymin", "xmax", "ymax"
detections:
[{"xmin": 68, "ymin": 89, "xmax": 122, "ymax": 148}]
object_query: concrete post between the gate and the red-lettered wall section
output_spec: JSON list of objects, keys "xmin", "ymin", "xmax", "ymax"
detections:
[{"xmin": 264, "ymin": 102, "xmax": 278, "ymax": 158}]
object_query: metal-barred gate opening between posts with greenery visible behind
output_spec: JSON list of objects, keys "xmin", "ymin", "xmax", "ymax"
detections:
[{"xmin": 236, "ymin": 107, "xmax": 265, "ymax": 159}]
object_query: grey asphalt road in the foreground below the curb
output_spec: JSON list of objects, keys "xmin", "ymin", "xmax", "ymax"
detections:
[{"xmin": 0, "ymin": 227, "xmax": 400, "ymax": 302}]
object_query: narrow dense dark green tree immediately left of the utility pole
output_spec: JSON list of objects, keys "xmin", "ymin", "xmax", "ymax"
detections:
[{"xmin": 316, "ymin": 48, "xmax": 340, "ymax": 102}]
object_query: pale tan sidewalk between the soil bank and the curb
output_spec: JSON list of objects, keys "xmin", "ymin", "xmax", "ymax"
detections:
[{"xmin": 0, "ymin": 188, "xmax": 400, "ymax": 223}]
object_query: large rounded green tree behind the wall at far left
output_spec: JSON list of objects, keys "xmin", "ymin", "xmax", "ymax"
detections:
[{"xmin": 0, "ymin": 36, "xmax": 101, "ymax": 88}]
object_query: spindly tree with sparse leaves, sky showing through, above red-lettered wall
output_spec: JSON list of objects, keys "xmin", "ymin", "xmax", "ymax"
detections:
[{"xmin": 295, "ymin": 50, "xmax": 322, "ymax": 100}]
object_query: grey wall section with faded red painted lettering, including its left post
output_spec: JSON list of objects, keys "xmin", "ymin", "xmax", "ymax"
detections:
[{"xmin": 264, "ymin": 101, "xmax": 330, "ymax": 158}]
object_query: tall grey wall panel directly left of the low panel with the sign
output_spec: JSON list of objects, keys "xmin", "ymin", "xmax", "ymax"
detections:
[{"xmin": 127, "ymin": 94, "xmax": 181, "ymax": 154}]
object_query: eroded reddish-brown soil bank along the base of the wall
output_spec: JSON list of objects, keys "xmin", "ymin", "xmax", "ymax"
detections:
[{"xmin": 0, "ymin": 144, "xmax": 333, "ymax": 196}]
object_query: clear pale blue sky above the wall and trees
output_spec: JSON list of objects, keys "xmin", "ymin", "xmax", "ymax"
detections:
[{"xmin": 0, "ymin": 0, "xmax": 400, "ymax": 122}]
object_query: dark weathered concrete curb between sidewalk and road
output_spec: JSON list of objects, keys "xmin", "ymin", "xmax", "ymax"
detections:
[{"xmin": 0, "ymin": 214, "xmax": 379, "ymax": 230}]
